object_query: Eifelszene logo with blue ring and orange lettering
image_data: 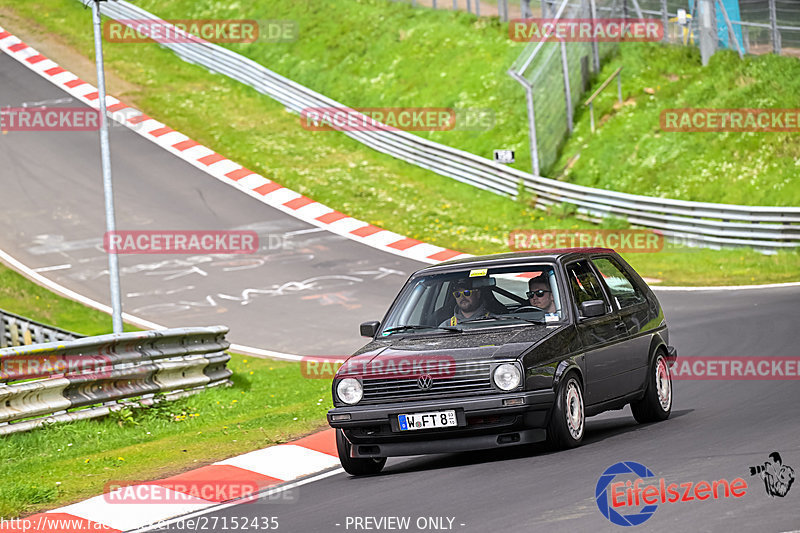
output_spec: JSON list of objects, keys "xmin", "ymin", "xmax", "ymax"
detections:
[{"xmin": 595, "ymin": 461, "xmax": 752, "ymax": 526}]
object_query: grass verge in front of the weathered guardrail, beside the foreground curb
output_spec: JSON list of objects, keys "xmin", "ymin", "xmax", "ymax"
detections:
[{"xmin": 0, "ymin": 354, "xmax": 332, "ymax": 518}]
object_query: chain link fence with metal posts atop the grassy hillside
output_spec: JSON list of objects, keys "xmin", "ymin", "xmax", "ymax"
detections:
[{"xmin": 509, "ymin": 0, "xmax": 800, "ymax": 175}]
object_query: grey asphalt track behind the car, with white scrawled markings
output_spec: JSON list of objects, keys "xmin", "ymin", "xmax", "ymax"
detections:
[{"xmin": 0, "ymin": 54, "xmax": 424, "ymax": 356}]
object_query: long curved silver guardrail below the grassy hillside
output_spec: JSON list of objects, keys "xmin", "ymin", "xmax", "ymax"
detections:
[{"xmin": 78, "ymin": 0, "xmax": 800, "ymax": 252}]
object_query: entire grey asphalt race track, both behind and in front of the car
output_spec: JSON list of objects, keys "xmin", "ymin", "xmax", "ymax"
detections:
[{"xmin": 0, "ymin": 36, "xmax": 800, "ymax": 533}]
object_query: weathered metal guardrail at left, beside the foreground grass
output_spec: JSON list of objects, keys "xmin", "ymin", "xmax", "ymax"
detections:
[{"xmin": 0, "ymin": 326, "xmax": 232, "ymax": 435}]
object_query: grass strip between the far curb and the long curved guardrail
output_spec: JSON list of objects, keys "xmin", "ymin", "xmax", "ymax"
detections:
[{"xmin": 0, "ymin": 0, "xmax": 800, "ymax": 285}]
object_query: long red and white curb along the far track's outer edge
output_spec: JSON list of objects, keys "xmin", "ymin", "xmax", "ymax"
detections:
[{"xmin": 0, "ymin": 26, "xmax": 469, "ymax": 263}]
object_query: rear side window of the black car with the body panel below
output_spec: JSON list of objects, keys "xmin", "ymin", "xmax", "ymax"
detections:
[{"xmin": 592, "ymin": 256, "xmax": 650, "ymax": 384}]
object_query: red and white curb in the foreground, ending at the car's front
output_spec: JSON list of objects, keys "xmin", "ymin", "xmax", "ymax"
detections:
[{"xmin": 0, "ymin": 429, "xmax": 339, "ymax": 533}]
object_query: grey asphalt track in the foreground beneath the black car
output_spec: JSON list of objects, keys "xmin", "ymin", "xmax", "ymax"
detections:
[{"xmin": 144, "ymin": 287, "xmax": 800, "ymax": 533}]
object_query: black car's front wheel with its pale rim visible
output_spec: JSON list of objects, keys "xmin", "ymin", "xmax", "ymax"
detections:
[{"xmin": 547, "ymin": 372, "xmax": 586, "ymax": 450}]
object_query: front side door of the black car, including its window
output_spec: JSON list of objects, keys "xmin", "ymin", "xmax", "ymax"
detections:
[{"xmin": 565, "ymin": 259, "xmax": 627, "ymax": 405}]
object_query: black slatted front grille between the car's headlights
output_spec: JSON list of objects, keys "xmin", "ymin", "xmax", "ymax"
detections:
[{"xmin": 360, "ymin": 361, "xmax": 496, "ymax": 404}]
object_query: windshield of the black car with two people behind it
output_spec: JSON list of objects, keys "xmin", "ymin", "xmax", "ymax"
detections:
[{"xmin": 381, "ymin": 264, "xmax": 563, "ymax": 336}]
